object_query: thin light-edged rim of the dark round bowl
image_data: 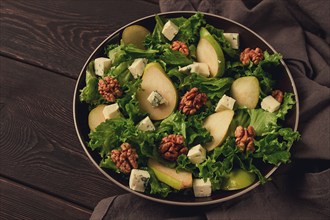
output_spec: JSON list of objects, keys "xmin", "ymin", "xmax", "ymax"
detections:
[{"xmin": 73, "ymin": 11, "xmax": 299, "ymax": 206}]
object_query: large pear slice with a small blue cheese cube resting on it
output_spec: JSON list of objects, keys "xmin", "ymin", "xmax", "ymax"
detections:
[{"xmin": 136, "ymin": 62, "xmax": 178, "ymax": 120}]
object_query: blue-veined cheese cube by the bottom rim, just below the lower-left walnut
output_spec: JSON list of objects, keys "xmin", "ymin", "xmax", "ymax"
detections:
[{"xmin": 129, "ymin": 169, "xmax": 150, "ymax": 192}]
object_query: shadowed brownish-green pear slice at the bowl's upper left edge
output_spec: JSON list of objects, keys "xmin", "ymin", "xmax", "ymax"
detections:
[{"xmin": 122, "ymin": 25, "xmax": 150, "ymax": 50}]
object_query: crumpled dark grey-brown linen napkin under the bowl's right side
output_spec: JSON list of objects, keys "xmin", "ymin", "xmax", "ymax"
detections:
[{"xmin": 91, "ymin": 0, "xmax": 330, "ymax": 219}]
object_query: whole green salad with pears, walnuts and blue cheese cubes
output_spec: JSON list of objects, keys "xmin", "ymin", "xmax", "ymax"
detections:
[{"xmin": 80, "ymin": 13, "xmax": 300, "ymax": 197}]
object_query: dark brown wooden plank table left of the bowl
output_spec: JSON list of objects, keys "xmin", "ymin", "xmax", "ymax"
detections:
[{"xmin": 0, "ymin": 0, "xmax": 159, "ymax": 219}]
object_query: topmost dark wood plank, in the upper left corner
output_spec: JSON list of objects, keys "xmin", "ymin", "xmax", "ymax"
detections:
[{"xmin": 0, "ymin": 0, "xmax": 159, "ymax": 78}]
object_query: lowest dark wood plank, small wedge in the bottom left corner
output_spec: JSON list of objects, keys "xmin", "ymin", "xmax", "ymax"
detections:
[{"xmin": 0, "ymin": 178, "xmax": 92, "ymax": 220}]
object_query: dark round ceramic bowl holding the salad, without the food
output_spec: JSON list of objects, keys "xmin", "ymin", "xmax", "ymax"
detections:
[{"xmin": 73, "ymin": 11, "xmax": 299, "ymax": 206}]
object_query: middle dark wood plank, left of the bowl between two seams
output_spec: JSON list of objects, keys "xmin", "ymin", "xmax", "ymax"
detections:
[{"xmin": 0, "ymin": 57, "xmax": 124, "ymax": 209}]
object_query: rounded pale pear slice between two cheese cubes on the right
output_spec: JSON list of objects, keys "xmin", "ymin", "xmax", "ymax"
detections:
[{"xmin": 230, "ymin": 76, "xmax": 260, "ymax": 109}]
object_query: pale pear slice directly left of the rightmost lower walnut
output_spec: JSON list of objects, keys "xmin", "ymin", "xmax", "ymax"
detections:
[{"xmin": 203, "ymin": 109, "xmax": 234, "ymax": 151}]
